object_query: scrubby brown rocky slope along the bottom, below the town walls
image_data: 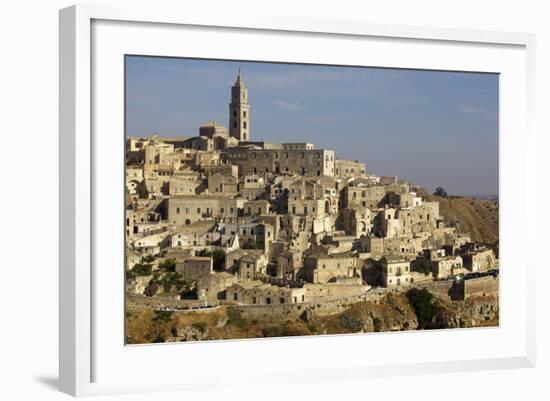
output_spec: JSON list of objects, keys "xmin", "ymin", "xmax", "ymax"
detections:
[{"xmin": 126, "ymin": 293, "xmax": 499, "ymax": 344}]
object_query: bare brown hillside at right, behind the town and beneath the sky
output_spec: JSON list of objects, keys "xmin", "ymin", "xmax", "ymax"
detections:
[{"xmin": 428, "ymin": 196, "xmax": 499, "ymax": 243}]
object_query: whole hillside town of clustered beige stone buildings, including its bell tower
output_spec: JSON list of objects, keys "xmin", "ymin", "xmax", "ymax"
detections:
[{"xmin": 126, "ymin": 72, "xmax": 497, "ymax": 304}]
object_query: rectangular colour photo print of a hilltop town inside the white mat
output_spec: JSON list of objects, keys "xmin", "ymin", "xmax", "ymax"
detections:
[{"xmin": 121, "ymin": 55, "xmax": 499, "ymax": 344}]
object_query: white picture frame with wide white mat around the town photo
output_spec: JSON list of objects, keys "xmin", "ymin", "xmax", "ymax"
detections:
[{"xmin": 60, "ymin": 5, "xmax": 537, "ymax": 396}]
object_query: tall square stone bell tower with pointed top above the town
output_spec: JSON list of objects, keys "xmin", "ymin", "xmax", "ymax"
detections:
[{"xmin": 229, "ymin": 69, "xmax": 250, "ymax": 142}]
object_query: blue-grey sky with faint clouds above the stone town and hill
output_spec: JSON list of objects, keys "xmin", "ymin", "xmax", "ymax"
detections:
[{"xmin": 126, "ymin": 56, "xmax": 498, "ymax": 195}]
